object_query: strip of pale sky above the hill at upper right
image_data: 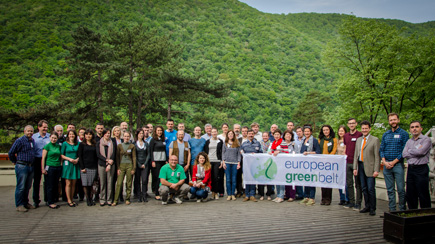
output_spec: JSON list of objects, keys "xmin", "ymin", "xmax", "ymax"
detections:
[{"xmin": 240, "ymin": 0, "xmax": 435, "ymax": 23}]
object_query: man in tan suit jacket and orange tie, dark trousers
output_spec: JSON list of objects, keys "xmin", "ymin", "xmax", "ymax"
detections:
[{"xmin": 353, "ymin": 120, "xmax": 381, "ymax": 216}]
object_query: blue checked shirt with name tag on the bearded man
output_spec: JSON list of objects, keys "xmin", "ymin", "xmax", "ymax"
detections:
[{"xmin": 379, "ymin": 127, "xmax": 409, "ymax": 162}]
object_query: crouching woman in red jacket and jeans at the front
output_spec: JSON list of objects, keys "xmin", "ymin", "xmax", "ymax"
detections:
[{"xmin": 190, "ymin": 152, "xmax": 211, "ymax": 202}]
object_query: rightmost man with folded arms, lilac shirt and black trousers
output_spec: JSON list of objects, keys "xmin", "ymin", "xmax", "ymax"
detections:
[{"xmin": 402, "ymin": 121, "xmax": 432, "ymax": 209}]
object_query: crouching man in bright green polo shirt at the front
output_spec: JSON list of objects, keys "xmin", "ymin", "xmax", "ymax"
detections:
[{"xmin": 159, "ymin": 155, "xmax": 190, "ymax": 205}]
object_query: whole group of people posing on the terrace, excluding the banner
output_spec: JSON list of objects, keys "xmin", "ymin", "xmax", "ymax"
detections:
[{"xmin": 9, "ymin": 113, "xmax": 432, "ymax": 215}]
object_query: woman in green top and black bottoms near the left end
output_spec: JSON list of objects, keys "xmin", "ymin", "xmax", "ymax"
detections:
[{"xmin": 41, "ymin": 132, "xmax": 62, "ymax": 209}]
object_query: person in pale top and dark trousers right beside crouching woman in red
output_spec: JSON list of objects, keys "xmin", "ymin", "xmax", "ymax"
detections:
[{"xmin": 204, "ymin": 128, "xmax": 225, "ymax": 200}]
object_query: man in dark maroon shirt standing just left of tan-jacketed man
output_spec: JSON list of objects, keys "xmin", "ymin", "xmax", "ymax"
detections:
[{"xmin": 343, "ymin": 118, "xmax": 362, "ymax": 211}]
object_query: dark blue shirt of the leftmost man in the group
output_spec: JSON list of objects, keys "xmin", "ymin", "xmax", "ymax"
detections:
[{"xmin": 8, "ymin": 136, "xmax": 35, "ymax": 163}]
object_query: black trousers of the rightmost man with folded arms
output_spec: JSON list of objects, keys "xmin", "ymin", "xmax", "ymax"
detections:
[{"xmin": 406, "ymin": 164, "xmax": 431, "ymax": 209}]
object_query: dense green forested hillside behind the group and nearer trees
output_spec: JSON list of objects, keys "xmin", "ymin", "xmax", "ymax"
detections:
[{"xmin": 0, "ymin": 0, "xmax": 435, "ymax": 145}]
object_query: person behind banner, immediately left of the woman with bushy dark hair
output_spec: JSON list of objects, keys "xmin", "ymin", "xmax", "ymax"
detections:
[{"xmin": 300, "ymin": 125, "xmax": 321, "ymax": 206}]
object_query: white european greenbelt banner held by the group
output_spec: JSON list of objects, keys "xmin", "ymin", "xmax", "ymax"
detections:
[{"xmin": 243, "ymin": 153, "xmax": 347, "ymax": 189}]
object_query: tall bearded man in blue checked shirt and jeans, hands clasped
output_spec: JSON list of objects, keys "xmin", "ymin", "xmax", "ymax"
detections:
[{"xmin": 379, "ymin": 113, "xmax": 409, "ymax": 211}]
